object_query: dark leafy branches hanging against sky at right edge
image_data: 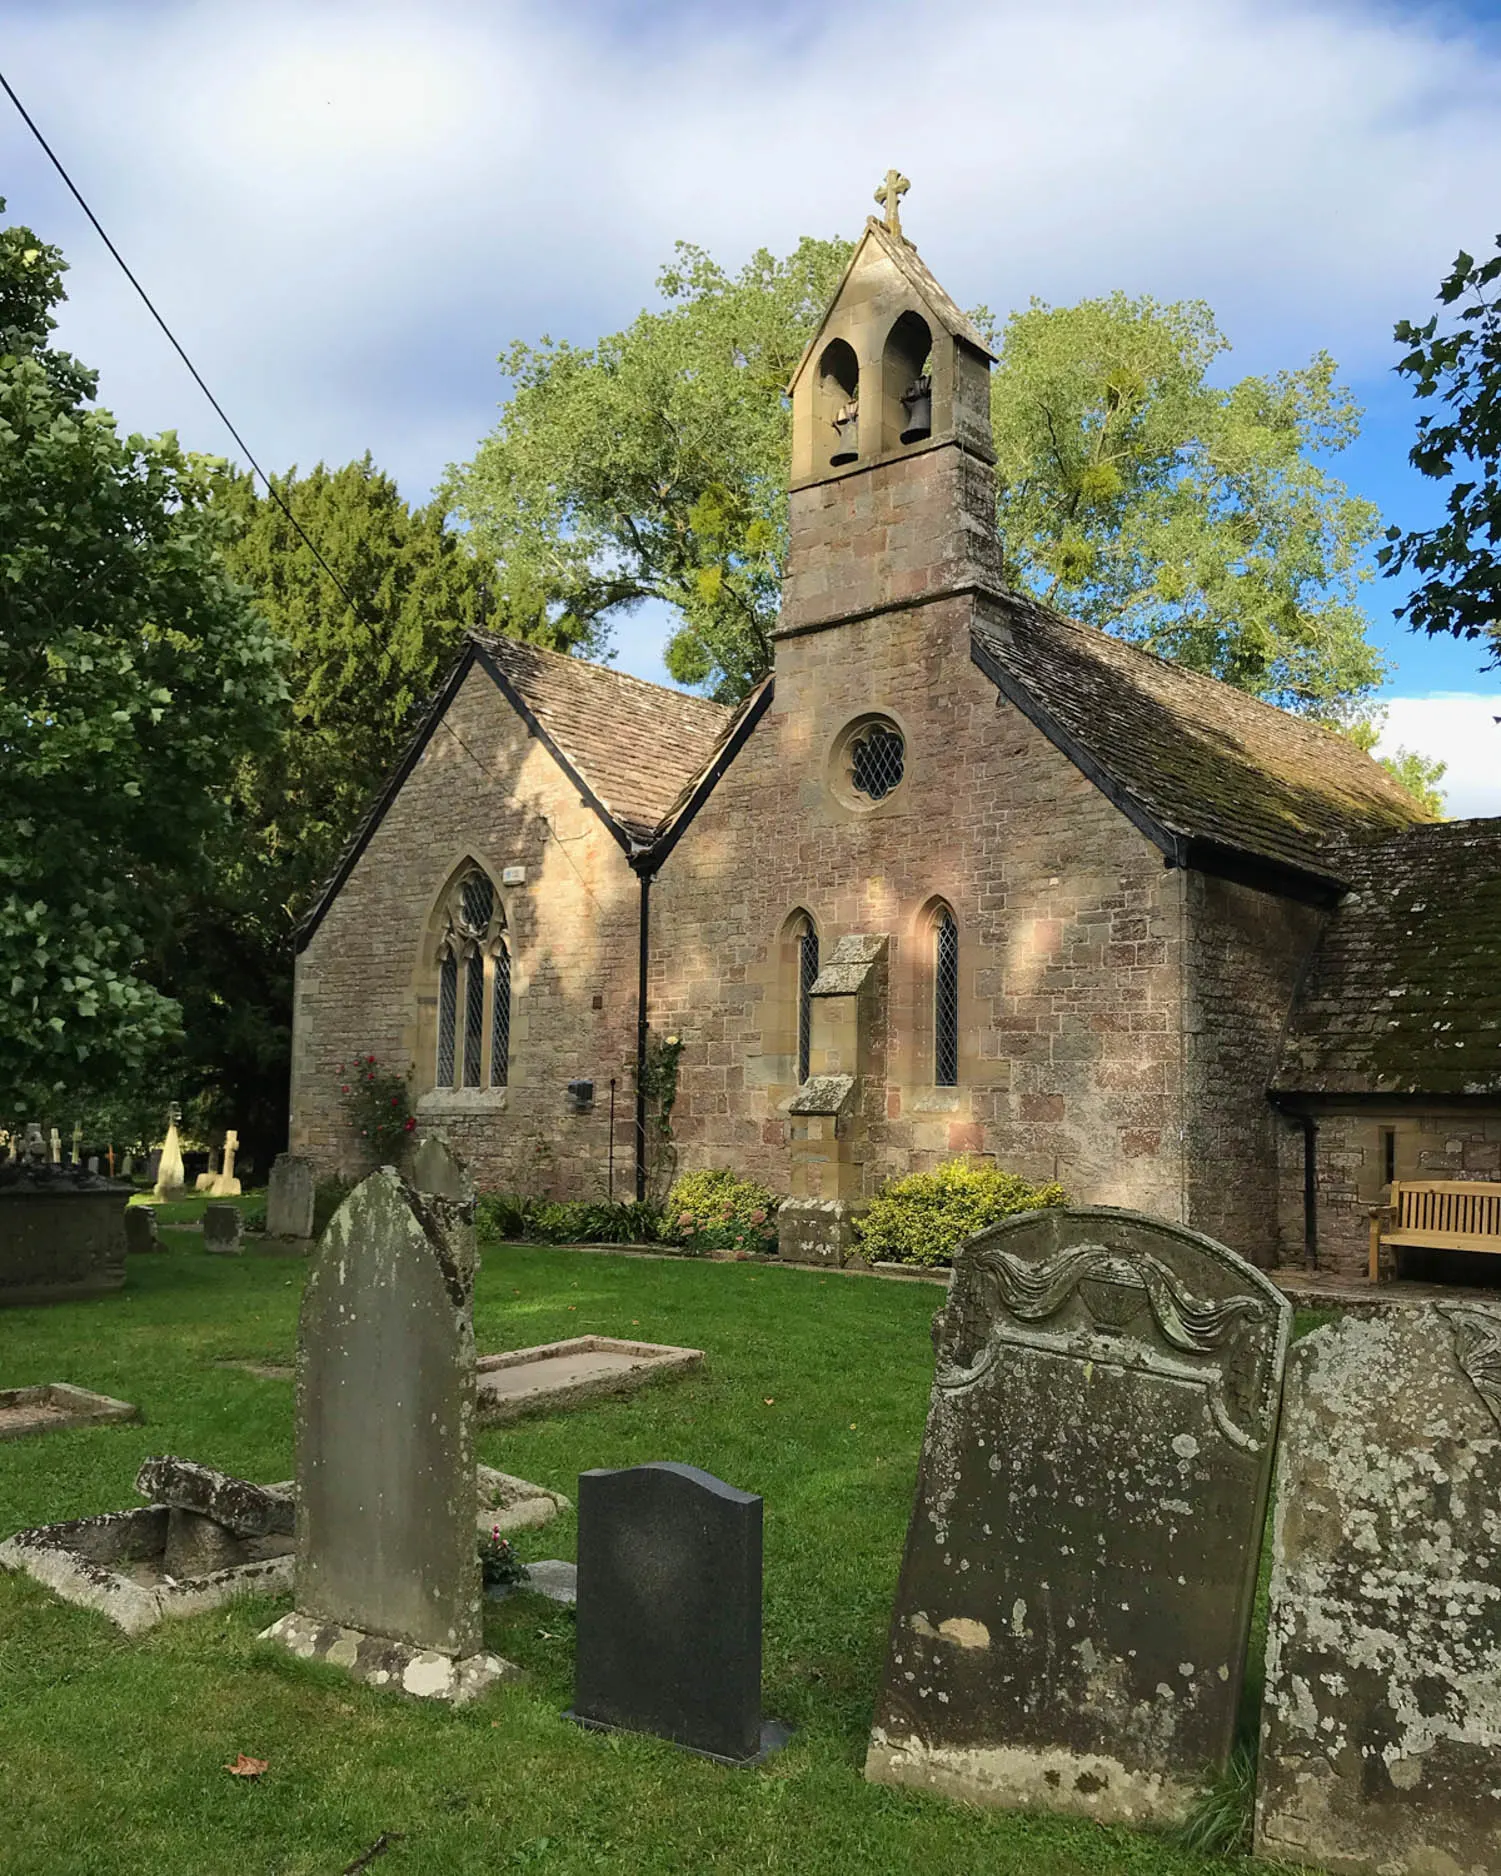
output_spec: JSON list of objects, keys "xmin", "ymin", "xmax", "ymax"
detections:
[{"xmin": 1379, "ymin": 235, "xmax": 1501, "ymax": 664}]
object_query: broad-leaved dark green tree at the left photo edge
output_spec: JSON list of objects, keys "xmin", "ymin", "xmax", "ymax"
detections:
[{"xmin": 0, "ymin": 203, "xmax": 285, "ymax": 1118}]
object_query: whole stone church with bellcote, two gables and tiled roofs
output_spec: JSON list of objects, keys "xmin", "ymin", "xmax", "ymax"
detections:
[{"xmin": 291, "ymin": 195, "xmax": 1501, "ymax": 1270}]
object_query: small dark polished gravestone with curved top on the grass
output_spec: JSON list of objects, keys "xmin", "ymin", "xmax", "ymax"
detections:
[{"xmin": 570, "ymin": 1465, "xmax": 786, "ymax": 1765}]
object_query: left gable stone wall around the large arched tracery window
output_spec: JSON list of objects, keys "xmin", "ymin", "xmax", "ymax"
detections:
[{"xmin": 291, "ymin": 668, "xmax": 640, "ymax": 1197}]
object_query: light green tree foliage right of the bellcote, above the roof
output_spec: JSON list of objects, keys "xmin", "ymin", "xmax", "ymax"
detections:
[{"xmin": 991, "ymin": 293, "xmax": 1383, "ymax": 722}]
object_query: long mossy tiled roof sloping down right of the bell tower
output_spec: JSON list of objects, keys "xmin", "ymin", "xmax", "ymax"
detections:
[{"xmin": 974, "ymin": 595, "xmax": 1422, "ymax": 880}]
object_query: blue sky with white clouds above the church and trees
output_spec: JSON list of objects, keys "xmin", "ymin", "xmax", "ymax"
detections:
[{"xmin": 0, "ymin": 0, "xmax": 1501, "ymax": 814}]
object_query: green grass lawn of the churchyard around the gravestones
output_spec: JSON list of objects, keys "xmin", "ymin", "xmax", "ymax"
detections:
[{"xmin": 0, "ymin": 1214, "xmax": 1268, "ymax": 1876}]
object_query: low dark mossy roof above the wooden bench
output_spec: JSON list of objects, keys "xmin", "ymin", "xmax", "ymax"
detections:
[{"xmin": 1272, "ymin": 818, "xmax": 1501, "ymax": 1094}]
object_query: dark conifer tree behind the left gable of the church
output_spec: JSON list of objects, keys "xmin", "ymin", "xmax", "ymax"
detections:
[{"xmin": 161, "ymin": 456, "xmax": 495, "ymax": 1165}]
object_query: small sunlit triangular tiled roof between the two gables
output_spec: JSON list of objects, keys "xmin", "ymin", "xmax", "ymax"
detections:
[{"xmin": 471, "ymin": 632, "xmax": 734, "ymax": 840}]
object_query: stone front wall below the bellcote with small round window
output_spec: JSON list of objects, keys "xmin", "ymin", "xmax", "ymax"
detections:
[{"xmin": 649, "ymin": 598, "xmax": 1186, "ymax": 1219}]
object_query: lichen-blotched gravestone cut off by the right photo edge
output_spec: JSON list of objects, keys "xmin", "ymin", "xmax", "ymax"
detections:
[{"xmin": 1255, "ymin": 1302, "xmax": 1501, "ymax": 1876}]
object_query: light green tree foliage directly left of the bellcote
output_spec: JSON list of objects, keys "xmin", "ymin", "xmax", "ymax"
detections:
[{"xmin": 448, "ymin": 238, "xmax": 850, "ymax": 700}]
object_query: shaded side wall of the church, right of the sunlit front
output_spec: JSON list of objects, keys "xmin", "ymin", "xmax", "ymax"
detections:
[{"xmin": 1184, "ymin": 872, "xmax": 1327, "ymax": 1266}]
